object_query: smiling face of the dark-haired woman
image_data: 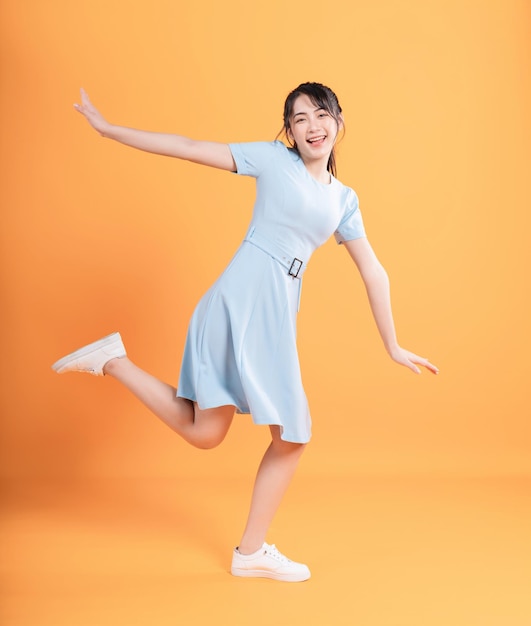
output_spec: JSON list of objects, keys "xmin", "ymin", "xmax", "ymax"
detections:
[{"xmin": 288, "ymin": 94, "xmax": 339, "ymax": 161}]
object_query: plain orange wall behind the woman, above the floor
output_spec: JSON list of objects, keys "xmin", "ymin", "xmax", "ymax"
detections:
[{"xmin": 0, "ymin": 0, "xmax": 531, "ymax": 476}]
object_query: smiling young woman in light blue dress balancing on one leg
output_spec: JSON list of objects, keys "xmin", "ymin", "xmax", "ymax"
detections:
[{"xmin": 53, "ymin": 83, "xmax": 438, "ymax": 581}]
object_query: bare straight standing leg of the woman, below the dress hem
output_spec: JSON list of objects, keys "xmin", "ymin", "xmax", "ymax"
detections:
[{"xmin": 238, "ymin": 426, "xmax": 305, "ymax": 554}]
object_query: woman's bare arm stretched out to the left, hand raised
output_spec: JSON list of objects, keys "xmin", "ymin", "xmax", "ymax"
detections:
[{"xmin": 74, "ymin": 89, "xmax": 236, "ymax": 172}]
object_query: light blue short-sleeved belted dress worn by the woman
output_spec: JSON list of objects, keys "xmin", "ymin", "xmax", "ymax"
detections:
[{"xmin": 177, "ymin": 141, "xmax": 365, "ymax": 443}]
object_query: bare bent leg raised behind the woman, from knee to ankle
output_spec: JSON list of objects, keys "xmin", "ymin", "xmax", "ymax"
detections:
[{"xmin": 103, "ymin": 357, "xmax": 234, "ymax": 449}]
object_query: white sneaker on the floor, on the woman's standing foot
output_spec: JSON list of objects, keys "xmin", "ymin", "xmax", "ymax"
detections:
[{"xmin": 230, "ymin": 543, "xmax": 311, "ymax": 583}]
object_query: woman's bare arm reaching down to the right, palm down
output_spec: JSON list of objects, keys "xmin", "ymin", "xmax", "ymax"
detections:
[{"xmin": 344, "ymin": 237, "xmax": 439, "ymax": 374}]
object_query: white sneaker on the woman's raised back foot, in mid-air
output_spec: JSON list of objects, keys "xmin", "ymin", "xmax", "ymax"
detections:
[{"xmin": 52, "ymin": 333, "xmax": 126, "ymax": 376}]
